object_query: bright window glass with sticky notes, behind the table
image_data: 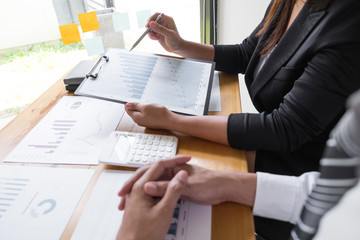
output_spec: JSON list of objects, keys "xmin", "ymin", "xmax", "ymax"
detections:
[{"xmin": 0, "ymin": 0, "xmax": 201, "ymax": 129}]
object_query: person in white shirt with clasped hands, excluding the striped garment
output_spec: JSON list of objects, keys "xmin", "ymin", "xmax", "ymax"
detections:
[{"xmin": 118, "ymin": 91, "xmax": 360, "ymax": 239}]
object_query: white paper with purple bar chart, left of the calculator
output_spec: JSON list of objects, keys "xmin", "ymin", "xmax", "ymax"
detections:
[{"xmin": 4, "ymin": 96, "xmax": 125, "ymax": 165}]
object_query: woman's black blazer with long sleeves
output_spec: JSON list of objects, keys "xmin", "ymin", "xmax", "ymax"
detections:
[{"xmin": 214, "ymin": 0, "xmax": 360, "ymax": 239}]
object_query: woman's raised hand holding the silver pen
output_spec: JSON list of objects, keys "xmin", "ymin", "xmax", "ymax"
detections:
[{"xmin": 146, "ymin": 13, "xmax": 184, "ymax": 53}]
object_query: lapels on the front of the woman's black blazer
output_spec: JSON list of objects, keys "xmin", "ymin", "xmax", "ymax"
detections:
[{"xmin": 245, "ymin": 7, "xmax": 326, "ymax": 98}]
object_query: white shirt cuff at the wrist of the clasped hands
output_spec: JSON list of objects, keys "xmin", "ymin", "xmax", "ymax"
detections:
[{"xmin": 253, "ymin": 172, "xmax": 319, "ymax": 224}]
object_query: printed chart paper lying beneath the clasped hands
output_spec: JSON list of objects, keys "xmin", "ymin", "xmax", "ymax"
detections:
[{"xmin": 71, "ymin": 170, "xmax": 211, "ymax": 240}]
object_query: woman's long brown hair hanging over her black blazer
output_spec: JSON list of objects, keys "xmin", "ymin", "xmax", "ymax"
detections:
[{"xmin": 256, "ymin": 0, "xmax": 331, "ymax": 57}]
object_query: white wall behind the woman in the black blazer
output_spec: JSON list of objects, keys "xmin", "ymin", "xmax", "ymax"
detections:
[{"xmin": 217, "ymin": 0, "xmax": 270, "ymax": 112}]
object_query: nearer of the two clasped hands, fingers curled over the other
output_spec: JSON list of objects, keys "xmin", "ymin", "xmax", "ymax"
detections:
[{"xmin": 117, "ymin": 157, "xmax": 190, "ymax": 240}]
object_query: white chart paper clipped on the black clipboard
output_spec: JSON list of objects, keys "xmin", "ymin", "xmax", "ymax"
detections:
[{"xmin": 75, "ymin": 48, "xmax": 215, "ymax": 115}]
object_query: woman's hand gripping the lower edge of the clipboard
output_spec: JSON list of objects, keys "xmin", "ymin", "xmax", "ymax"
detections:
[{"xmin": 125, "ymin": 103, "xmax": 176, "ymax": 130}]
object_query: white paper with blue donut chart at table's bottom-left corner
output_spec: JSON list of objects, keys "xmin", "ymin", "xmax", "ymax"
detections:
[{"xmin": 0, "ymin": 165, "xmax": 94, "ymax": 240}]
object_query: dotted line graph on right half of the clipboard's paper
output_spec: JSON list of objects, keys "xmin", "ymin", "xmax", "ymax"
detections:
[{"xmin": 142, "ymin": 58, "xmax": 208, "ymax": 109}]
